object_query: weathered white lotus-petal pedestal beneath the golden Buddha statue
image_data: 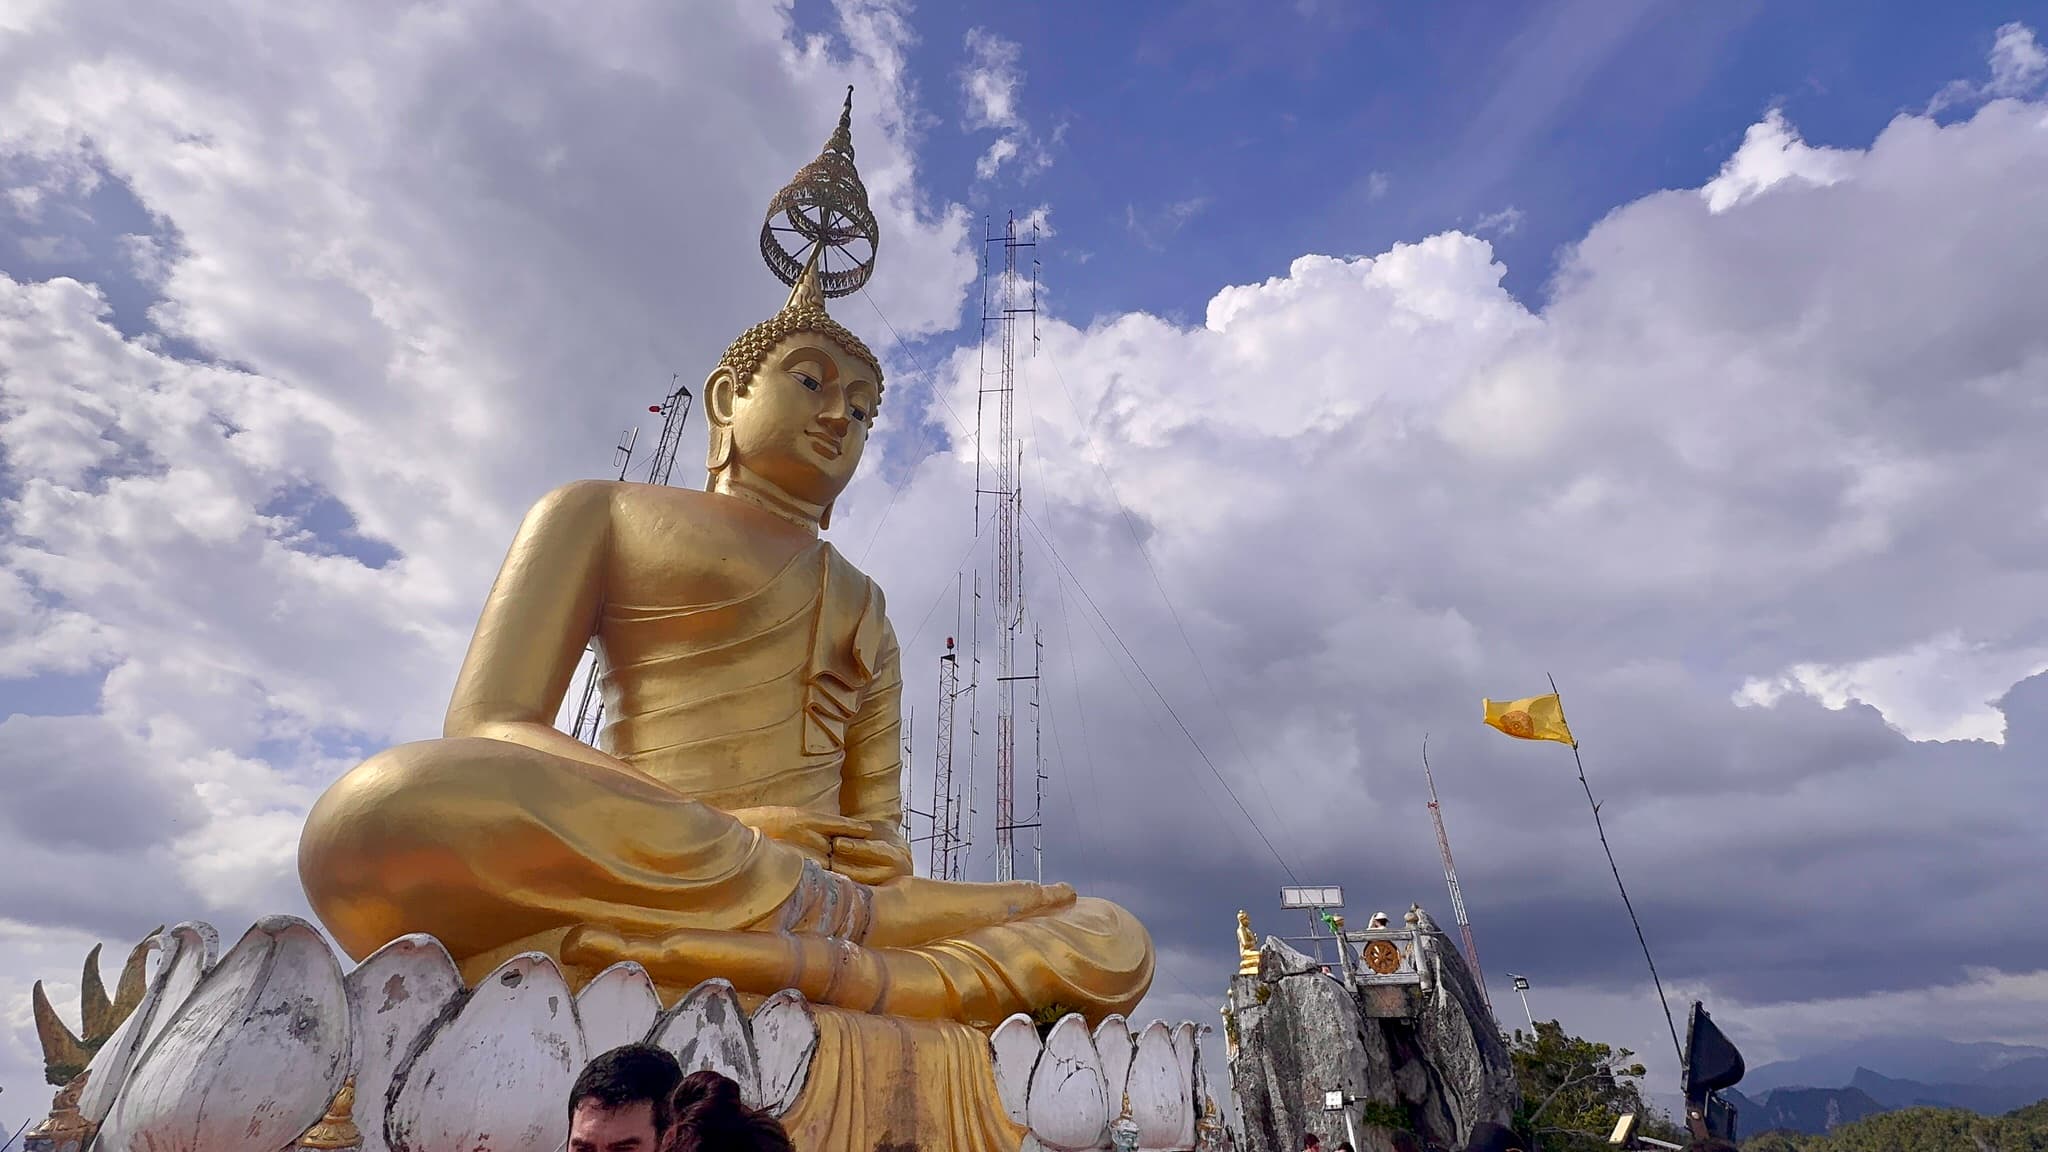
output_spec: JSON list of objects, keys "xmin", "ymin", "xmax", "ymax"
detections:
[{"xmin": 48, "ymin": 916, "xmax": 1208, "ymax": 1152}]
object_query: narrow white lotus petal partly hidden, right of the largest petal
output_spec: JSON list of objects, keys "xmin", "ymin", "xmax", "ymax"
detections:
[{"xmin": 342, "ymin": 933, "xmax": 463, "ymax": 1152}]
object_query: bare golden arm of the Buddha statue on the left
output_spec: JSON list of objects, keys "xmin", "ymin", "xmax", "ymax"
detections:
[{"xmin": 444, "ymin": 480, "xmax": 633, "ymax": 771}]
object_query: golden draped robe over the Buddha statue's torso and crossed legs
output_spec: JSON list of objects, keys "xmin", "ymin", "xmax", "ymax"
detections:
[{"xmin": 301, "ymin": 528, "xmax": 1151, "ymax": 1027}]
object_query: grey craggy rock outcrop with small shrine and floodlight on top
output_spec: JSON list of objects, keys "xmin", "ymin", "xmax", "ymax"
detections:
[{"xmin": 1225, "ymin": 908, "xmax": 1518, "ymax": 1152}]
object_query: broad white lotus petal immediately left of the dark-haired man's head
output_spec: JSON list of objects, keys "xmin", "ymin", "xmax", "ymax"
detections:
[{"xmin": 383, "ymin": 951, "xmax": 588, "ymax": 1152}]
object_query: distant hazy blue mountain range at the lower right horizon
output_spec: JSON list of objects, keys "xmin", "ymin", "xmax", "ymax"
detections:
[{"xmin": 1726, "ymin": 1037, "xmax": 2048, "ymax": 1136}]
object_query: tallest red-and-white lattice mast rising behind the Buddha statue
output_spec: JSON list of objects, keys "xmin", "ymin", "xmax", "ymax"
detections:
[{"xmin": 975, "ymin": 213, "xmax": 1042, "ymax": 879}]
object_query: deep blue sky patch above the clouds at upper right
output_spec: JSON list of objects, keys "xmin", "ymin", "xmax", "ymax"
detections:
[{"xmin": 797, "ymin": 0, "xmax": 2030, "ymax": 322}]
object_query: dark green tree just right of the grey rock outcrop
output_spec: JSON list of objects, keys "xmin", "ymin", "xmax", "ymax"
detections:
[{"xmin": 1509, "ymin": 1021, "xmax": 1679, "ymax": 1152}]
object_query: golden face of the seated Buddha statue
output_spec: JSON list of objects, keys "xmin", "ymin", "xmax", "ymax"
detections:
[{"xmin": 731, "ymin": 332, "xmax": 881, "ymax": 504}]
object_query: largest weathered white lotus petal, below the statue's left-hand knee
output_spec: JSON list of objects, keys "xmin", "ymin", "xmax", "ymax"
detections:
[{"xmin": 98, "ymin": 916, "xmax": 348, "ymax": 1152}]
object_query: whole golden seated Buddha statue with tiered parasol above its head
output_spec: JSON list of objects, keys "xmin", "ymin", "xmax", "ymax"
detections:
[{"xmin": 299, "ymin": 85, "xmax": 1153, "ymax": 1027}]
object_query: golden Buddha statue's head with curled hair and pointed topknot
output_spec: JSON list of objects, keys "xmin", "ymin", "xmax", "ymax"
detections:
[{"xmin": 705, "ymin": 255, "xmax": 883, "ymax": 527}]
